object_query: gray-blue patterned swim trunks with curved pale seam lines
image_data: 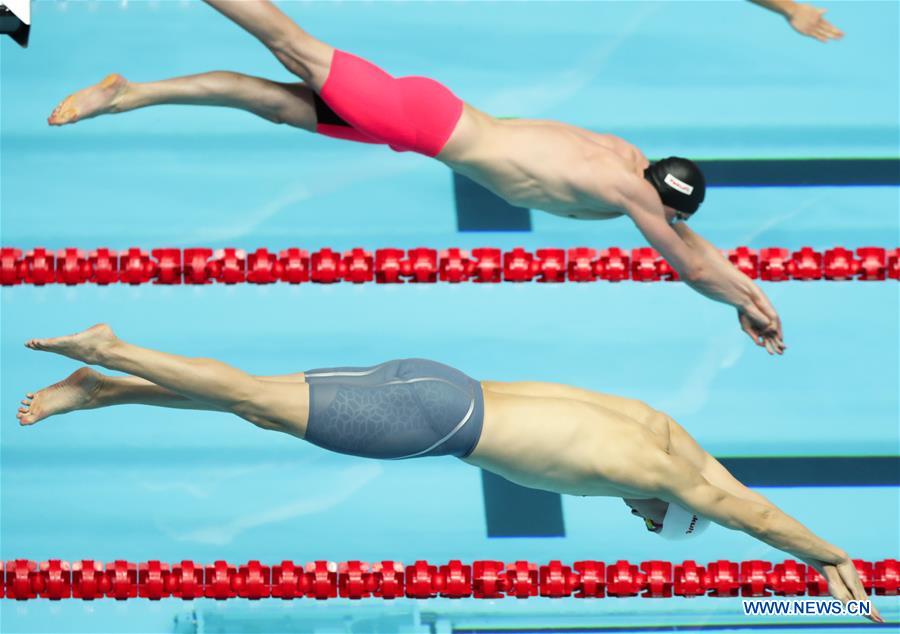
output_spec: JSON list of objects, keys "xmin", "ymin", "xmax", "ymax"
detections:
[{"xmin": 306, "ymin": 359, "xmax": 484, "ymax": 460}]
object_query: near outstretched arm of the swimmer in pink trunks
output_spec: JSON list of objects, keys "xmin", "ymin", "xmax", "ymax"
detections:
[{"xmin": 612, "ymin": 174, "xmax": 784, "ymax": 353}]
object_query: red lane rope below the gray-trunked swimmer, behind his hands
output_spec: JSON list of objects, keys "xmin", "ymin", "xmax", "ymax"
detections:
[{"xmin": 0, "ymin": 559, "xmax": 900, "ymax": 601}]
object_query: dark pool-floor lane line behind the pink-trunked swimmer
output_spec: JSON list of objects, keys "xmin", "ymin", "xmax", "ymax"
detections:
[{"xmin": 453, "ymin": 159, "xmax": 900, "ymax": 232}]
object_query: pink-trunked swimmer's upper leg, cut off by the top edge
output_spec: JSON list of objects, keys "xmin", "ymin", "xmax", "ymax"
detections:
[{"xmin": 206, "ymin": 0, "xmax": 334, "ymax": 87}]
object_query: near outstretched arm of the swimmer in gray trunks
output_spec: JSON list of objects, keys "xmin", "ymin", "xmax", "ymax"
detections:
[{"xmin": 641, "ymin": 451, "xmax": 884, "ymax": 623}]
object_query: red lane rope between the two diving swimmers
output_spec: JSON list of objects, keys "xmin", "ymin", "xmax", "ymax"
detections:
[{"xmin": 0, "ymin": 247, "xmax": 900, "ymax": 286}]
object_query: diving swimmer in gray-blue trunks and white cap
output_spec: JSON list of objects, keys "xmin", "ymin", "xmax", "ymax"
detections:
[{"xmin": 17, "ymin": 324, "xmax": 882, "ymax": 622}]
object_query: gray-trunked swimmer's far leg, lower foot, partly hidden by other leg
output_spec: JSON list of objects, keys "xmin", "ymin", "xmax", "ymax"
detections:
[{"xmin": 16, "ymin": 367, "xmax": 305, "ymax": 429}]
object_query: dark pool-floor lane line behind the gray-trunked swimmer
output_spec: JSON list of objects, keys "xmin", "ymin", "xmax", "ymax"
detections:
[{"xmin": 481, "ymin": 456, "xmax": 900, "ymax": 537}]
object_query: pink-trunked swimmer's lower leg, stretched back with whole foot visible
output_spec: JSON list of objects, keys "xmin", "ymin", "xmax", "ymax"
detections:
[{"xmin": 47, "ymin": 71, "xmax": 316, "ymax": 132}]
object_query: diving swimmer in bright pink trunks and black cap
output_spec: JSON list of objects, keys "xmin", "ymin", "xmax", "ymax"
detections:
[{"xmin": 48, "ymin": 0, "xmax": 786, "ymax": 355}]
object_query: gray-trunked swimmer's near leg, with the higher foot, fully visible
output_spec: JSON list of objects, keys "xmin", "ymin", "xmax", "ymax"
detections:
[{"xmin": 25, "ymin": 325, "xmax": 309, "ymax": 438}]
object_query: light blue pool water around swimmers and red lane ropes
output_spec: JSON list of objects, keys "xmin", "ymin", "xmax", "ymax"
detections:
[{"xmin": 0, "ymin": 2, "xmax": 900, "ymax": 633}]
